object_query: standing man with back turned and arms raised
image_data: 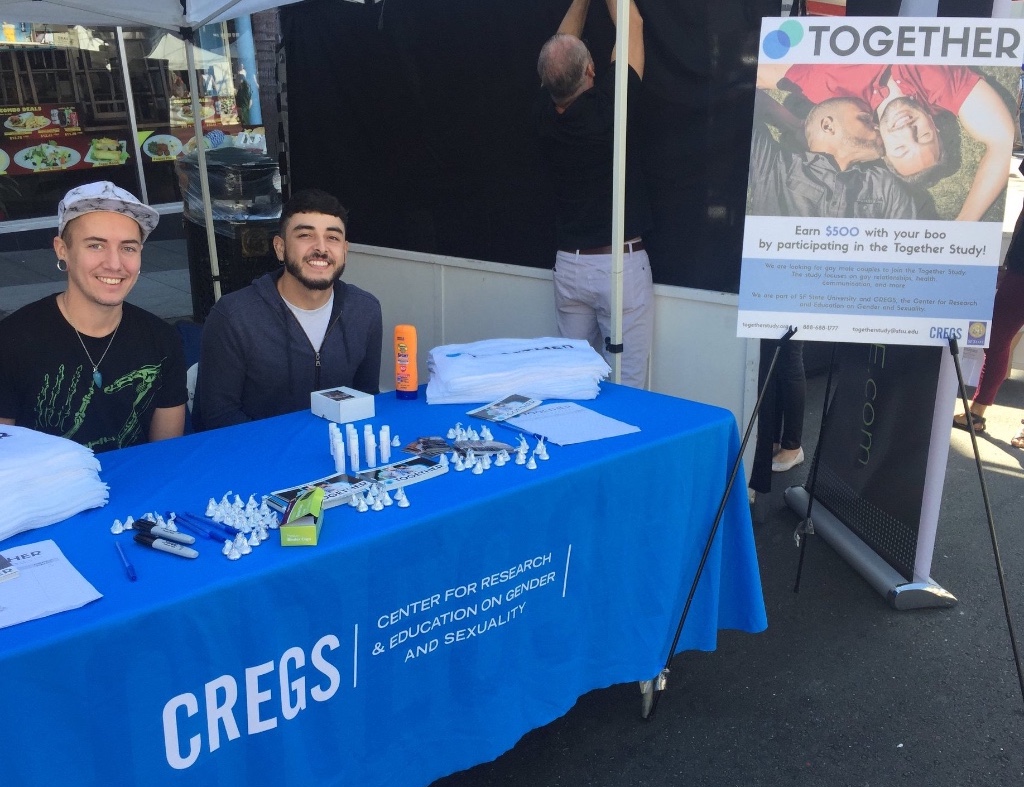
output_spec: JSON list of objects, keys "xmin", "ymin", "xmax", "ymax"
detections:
[{"xmin": 537, "ymin": 0, "xmax": 654, "ymax": 388}]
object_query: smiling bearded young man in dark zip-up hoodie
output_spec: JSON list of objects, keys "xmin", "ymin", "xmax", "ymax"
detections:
[{"xmin": 193, "ymin": 189, "xmax": 383, "ymax": 429}]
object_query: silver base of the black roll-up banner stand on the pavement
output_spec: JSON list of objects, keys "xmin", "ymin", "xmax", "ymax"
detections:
[{"xmin": 782, "ymin": 486, "xmax": 956, "ymax": 610}]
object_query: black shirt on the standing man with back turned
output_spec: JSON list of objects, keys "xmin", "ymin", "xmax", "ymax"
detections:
[{"xmin": 538, "ymin": 68, "xmax": 650, "ymax": 251}]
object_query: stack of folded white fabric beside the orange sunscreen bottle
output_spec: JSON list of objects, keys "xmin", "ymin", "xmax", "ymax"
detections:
[{"xmin": 427, "ymin": 338, "xmax": 611, "ymax": 404}]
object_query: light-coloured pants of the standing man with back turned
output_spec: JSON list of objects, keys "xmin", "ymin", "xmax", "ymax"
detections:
[{"xmin": 554, "ymin": 250, "xmax": 654, "ymax": 388}]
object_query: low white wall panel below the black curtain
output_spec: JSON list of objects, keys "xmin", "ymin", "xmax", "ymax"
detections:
[{"xmin": 345, "ymin": 245, "xmax": 758, "ymax": 454}]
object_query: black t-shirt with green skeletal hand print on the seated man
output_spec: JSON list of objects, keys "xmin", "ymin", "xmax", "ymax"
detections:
[{"xmin": 0, "ymin": 296, "xmax": 187, "ymax": 452}]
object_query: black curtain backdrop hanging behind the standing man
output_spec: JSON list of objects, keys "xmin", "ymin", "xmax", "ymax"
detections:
[{"xmin": 281, "ymin": 0, "xmax": 991, "ymax": 293}]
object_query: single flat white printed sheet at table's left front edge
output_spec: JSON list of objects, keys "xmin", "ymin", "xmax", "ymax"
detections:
[{"xmin": 0, "ymin": 540, "xmax": 102, "ymax": 628}]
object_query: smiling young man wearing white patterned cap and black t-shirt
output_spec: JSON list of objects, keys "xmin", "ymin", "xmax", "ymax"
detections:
[{"xmin": 0, "ymin": 181, "xmax": 187, "ymax": 451}]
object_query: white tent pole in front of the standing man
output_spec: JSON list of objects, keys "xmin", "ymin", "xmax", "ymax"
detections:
[{"xmin": 610, "ymin": 0, "xmax": 630, "ymax": 383}]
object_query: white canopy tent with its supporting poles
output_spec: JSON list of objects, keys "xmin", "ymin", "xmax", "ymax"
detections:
[{"xmin": 0, "ymin": 0, "xmax": 630, "ymax": 382}]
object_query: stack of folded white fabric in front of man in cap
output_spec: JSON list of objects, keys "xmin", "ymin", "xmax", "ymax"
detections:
[{"xmin": 0, "ymin": 426, "xmax": 109, "ymax": 540}]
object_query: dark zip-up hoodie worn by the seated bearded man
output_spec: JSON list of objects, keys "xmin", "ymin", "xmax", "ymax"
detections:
[{"xmin": 193, "ymin": 268, "xmax": 383, "ymax": 429}]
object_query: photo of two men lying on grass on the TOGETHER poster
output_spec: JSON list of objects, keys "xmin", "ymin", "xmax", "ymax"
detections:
[{"xmin": 746, "ymin": 61, "xmax": 1020, "ymax": 222}]
